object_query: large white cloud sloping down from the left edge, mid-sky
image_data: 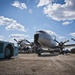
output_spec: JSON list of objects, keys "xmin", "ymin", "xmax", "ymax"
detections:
[{"xmin": 0, "ymin": 16, "xmax": 26, "ymax": 31}]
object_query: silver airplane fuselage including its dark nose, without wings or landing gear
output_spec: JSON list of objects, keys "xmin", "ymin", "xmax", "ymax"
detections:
[{"xmin": 34, "ymin": 31, "xmax": 56, "ymax": 48}]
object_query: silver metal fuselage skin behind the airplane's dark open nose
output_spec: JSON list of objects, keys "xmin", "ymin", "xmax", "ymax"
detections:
[{"xmin": 37, "ymin": 31, "xmax": 56, "ymax": 48}]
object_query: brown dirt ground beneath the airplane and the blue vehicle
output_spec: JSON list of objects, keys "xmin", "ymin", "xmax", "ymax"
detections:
[{"xmin": 0, "ymin": 53, "xmax": 75, "ymax": 75}]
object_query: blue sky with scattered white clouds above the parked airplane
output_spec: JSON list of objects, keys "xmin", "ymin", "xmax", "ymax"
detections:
[{"xmin": 0, "ymin": 0, "xmax": 75, "ymax": 43}]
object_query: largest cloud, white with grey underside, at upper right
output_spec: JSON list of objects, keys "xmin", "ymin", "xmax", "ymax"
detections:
[{"xmin": 38, "ymin": 0, "xmax": 75, "ymax": 21}]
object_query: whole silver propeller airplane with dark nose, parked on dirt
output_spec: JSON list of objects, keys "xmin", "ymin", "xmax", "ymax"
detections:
[{"xmin": 14, "ymin": 30, "xmax": 75, "ymax": 55}]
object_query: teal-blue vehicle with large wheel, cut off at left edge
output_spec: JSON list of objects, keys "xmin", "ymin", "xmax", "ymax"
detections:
[{"xmin": 0, "ymin": 41, "xmax": 18, "ymax": 58}]
